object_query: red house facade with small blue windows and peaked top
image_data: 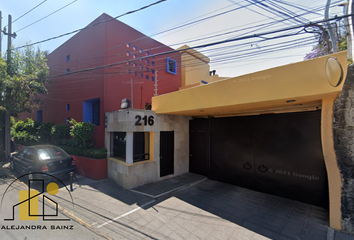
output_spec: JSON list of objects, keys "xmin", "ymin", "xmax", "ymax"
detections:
[{"xmin": 31, "ymin": 14, "xmax": 181, "ymax": 147}]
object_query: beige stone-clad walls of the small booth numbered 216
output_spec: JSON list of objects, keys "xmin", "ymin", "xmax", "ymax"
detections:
[{"xmin": 106, "ymin": 109, "xmax": 189, "ymax": 189}]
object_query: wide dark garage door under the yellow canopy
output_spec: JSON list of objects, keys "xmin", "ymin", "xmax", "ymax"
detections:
[{"xmin": 190, "ymin": 111, "xmax": 328, "ymax": 207}]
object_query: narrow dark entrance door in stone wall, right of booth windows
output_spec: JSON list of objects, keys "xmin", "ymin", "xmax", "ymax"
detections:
[{"xmin": 160, "ymin": 131, "xmax": 174, "ymax": 177}]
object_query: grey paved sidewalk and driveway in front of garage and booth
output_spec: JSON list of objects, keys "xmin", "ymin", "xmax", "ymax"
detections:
[{"xmin": 42, "ymin": 173, "xmax": 354, "ymax": 240}]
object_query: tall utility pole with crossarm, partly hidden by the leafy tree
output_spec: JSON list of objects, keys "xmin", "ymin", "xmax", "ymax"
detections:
[{"xmin": 3, "ymin": 15, "xmax": 16, "ymax": 159}]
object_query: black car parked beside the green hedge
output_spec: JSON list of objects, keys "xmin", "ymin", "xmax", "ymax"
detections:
[{"xmin": 10, "ymin": 145, "xmax": 75, "ymax": 180}]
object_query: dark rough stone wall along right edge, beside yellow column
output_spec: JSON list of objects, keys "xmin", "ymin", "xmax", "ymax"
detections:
[{"xmin": 333, "ymin": 65, "xmax": 354, "ymax": 234}]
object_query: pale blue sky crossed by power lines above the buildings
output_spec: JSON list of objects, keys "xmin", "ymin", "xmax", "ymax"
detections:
[{"xmin": 0, "ymin": 0, "xmax": 343, "ymax": 77}]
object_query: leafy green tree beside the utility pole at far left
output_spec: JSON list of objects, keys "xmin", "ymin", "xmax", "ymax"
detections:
[{"xmin": 0, "ymin": 46, "xmax": 49, "ymax": 158}]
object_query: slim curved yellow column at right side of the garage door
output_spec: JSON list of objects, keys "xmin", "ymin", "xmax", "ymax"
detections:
[{"xmin": 321, "ymin": 99, "xmax": 342, "ymax": 230}]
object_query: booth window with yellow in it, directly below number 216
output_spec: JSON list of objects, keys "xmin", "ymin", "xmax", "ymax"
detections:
[{"xmin": 133, "ymin": 132, "xmax": 150, "ymax": 162}]
